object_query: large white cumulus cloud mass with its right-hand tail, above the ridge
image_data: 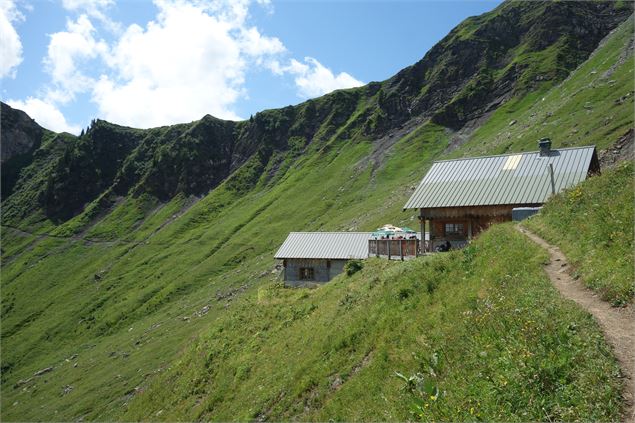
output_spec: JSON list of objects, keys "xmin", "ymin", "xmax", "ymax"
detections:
[{"xmin": 9, "ymin": 0, "xmax": 362, "ymax": 132}]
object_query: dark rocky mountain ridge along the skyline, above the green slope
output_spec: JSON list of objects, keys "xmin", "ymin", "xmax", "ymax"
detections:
[{"xmin": 2, "ymin": 2, "xmax": 631, "ymax": 229}]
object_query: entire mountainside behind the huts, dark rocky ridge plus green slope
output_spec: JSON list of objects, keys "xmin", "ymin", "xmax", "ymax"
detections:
[{"xmin": 1, "ymin": 2, "xmax": 633, "ymax": 420}]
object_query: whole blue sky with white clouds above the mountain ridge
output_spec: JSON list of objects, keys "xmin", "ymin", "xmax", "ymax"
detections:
[{"xmin": 0, "ymin": 0, "xmax": 500, "ymax": 133}]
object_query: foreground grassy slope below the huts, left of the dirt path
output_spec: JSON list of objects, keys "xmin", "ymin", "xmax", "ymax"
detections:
[{"xmin": 125, "ymin": 225, "xmax": 620, "ymax": 421}]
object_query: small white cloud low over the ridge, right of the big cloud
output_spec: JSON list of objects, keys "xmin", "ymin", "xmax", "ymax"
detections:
[{"xmin": 268, "ymin": 57, "xmax": 364, "ymax": 98}]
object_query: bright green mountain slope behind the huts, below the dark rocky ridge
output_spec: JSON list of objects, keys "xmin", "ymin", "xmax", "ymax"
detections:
[{"xmin": 1, "ymin": 14, "xmax": 633, "ymax": 420}]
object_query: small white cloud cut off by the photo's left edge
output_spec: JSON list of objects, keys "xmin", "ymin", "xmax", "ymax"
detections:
[{"xmin": 0, "ymin": 0, "xmax": 24, "ymax": 78}]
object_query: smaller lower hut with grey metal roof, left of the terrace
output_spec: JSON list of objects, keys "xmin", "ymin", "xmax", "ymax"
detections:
[{"xmin": 274, "ymin": 232, "xmax": 371, "ymax": 286}]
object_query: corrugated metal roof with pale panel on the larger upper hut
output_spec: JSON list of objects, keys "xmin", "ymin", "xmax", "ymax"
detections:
[{"xmin": 404, "ymin": 146, "xmax": 595, "ymax": 209}]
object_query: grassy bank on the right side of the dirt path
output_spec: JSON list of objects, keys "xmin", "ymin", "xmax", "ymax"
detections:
[{"xmin": 526, "ymin": 162, "xmax": 635, "ymax": 305}]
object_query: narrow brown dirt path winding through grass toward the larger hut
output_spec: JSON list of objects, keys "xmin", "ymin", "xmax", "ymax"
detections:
[{"xmin": 516, "ymin": 226, "xmax": 635, "ymax": 422}]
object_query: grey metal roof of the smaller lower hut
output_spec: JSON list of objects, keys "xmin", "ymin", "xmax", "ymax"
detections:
[{"xmin": 274, "ymin": 232, "xmax": 372, "ymax": 259}]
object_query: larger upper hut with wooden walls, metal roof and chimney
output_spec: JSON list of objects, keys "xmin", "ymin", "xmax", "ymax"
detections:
[{"xmin": 404, "ymin": 138, "xmax": 600, "ymax": 251}]
